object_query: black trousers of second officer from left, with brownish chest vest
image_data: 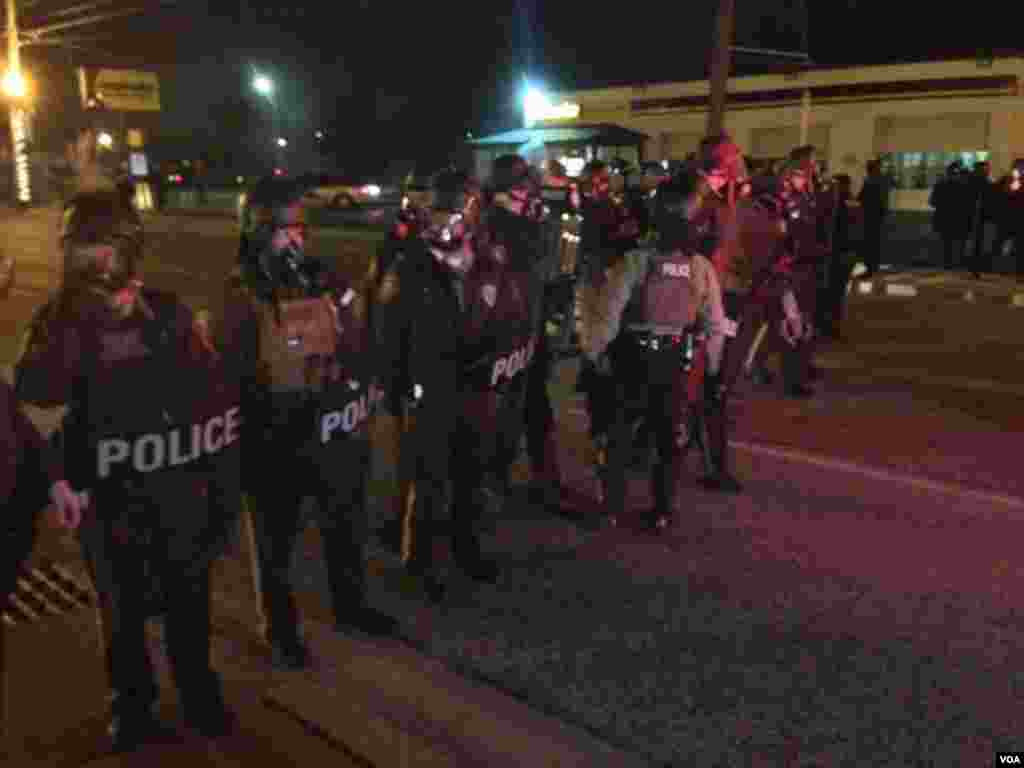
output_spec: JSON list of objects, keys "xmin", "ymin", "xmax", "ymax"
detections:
[{"xmin": 246, "ymin": 437, "xmax": 370, "ymax": 644}]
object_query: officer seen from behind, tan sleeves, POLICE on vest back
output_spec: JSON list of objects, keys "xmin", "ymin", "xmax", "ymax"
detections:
[{"xmin": 582, "ymin": 179, "xmax": 725, "ymax": 528}]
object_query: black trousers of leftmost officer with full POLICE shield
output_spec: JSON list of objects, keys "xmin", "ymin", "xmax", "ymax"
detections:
[{"xmin": 80, "ymin": 490, "xmax": 230, "ymax": 721}]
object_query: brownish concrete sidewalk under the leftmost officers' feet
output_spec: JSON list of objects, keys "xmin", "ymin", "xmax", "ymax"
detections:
[{"xmin": 0, "ymin": 530, "xmax": 647, "ymax": 768}]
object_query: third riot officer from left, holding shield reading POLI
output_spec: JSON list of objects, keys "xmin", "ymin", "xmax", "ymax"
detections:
[{"xmin": 378, "ymin": 166, "xmax": 536, "ymax": 589}]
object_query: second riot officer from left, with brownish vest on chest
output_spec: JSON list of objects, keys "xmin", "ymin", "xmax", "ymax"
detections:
[{"xmin": 220, "ymin": 177, "xmax": 397, "ymax": 669}]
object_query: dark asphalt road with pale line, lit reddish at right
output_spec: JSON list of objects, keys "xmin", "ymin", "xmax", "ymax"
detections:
[{"xmin": 6, "ymin": 207, "xmax": 1024, "ymax": 766}]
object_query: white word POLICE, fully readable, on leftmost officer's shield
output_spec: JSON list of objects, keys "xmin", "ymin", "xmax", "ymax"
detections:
[{"xmin": 96, "ymin": 406, "xmax": 240, "ymax": 479}]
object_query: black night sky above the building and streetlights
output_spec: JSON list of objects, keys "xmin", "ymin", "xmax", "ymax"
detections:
[{"xmin": 16, "ymin": 0, "xmax": 1024, "ymax": 176}]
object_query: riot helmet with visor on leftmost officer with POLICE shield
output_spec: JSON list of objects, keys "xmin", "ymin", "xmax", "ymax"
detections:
[{"xmin": 60, "ymin": 189, "xmax": 142, "ymax": 292}]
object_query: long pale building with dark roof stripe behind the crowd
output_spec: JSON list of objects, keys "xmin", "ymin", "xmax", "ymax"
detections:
[{"xmin": 544, "ymin": 57, "xmax": 1024, "ymax": 211}]
